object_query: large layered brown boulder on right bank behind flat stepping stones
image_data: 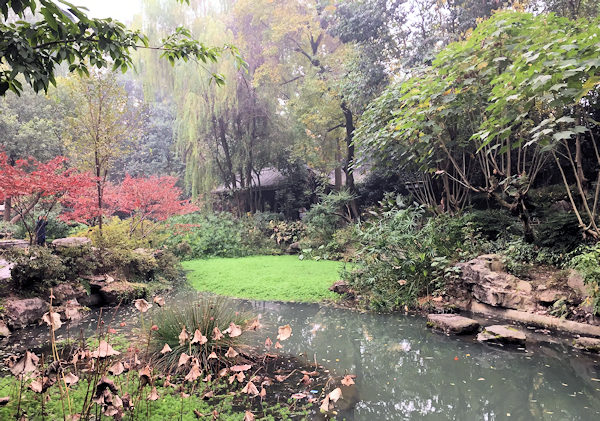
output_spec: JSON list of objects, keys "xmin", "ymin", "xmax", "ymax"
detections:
[{"xmin": 458, "ymin": 255, "xmax": 536, "ymax": 311}]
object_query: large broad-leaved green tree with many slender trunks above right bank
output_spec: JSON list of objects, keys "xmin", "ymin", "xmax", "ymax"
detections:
[{"xmin": 358, "ymin": 12, "xmax": 600, "ymax": 239}]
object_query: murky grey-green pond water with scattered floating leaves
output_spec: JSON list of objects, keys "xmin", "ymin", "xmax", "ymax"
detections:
[{"xmin": 5, "ymin": 293, "xmax": 600, "ymax": 421}]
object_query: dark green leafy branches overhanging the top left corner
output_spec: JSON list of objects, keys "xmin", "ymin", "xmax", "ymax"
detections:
[{"xmin": 0, "ymin": 0, "xmax": 236, "ymax": 95}]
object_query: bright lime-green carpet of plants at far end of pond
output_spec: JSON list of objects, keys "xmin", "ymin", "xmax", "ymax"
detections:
[{"xmin": 183, "ymin": 256, "xmax": 344, "ymax": 302}]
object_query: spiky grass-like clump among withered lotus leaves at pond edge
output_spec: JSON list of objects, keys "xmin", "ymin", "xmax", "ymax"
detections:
[{"xmin": 150, "ymin": 297, "xmax": 246, "ymax": 372}]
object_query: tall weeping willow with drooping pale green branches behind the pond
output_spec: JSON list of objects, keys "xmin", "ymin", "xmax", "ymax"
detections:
[{"xmin": 138, "ymin": 2, "xmax": 286, "ymax": 210}]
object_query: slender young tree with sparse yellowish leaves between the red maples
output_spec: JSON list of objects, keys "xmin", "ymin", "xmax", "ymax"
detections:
[{"xmin": 63, "ymin": 72, "xmax": 140, "ymax": 230}]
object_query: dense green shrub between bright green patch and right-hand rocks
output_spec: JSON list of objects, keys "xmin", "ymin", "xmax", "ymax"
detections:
[{"xmin": 345, "ymin": 207, "xmax": 476, "ymax": 311}]
